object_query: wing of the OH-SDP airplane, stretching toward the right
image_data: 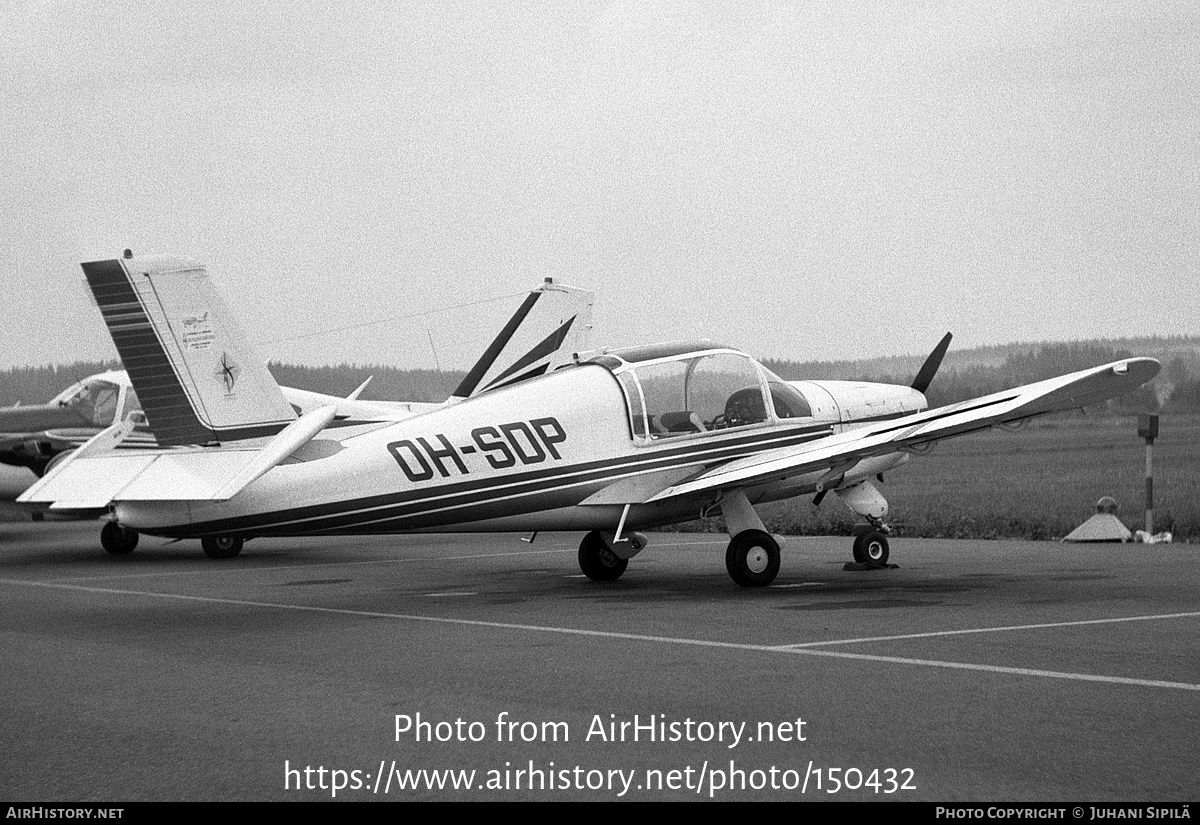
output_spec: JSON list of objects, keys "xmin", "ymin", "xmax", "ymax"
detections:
[{"xmin": 648, "ymin": 359, "xmax": 1159, "ymax": 501}]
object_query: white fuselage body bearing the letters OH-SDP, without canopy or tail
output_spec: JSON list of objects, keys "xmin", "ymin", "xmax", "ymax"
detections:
[{"xmin": 116, "ymin": 363, "xmax": 924, "ymax": 537}]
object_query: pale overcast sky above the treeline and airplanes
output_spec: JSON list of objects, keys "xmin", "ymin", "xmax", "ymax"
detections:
[{"xmin": 0, "ymin": 0, "xmax": 1200, "ymax": 367}]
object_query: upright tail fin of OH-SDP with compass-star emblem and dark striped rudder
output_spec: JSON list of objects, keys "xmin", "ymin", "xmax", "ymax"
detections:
[{"xmin": 82, "ymin": 253, "xmax": 296, "ymax": 446}]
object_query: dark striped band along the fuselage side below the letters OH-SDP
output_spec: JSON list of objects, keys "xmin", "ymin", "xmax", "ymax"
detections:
[{"xmin": 154, "ymin": 424, "xmax": 832, "ymax": 537}]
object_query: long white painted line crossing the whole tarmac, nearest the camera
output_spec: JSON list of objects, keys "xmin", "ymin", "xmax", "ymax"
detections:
[{"xmin": 9, "ymin": 579, "xmax": 1200, "ymax": 692}]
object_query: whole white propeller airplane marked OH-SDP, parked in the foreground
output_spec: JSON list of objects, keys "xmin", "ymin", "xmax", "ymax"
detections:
[{"xmin": 20, "ymin": 257, "xmax": 1159, "ymax": 586}]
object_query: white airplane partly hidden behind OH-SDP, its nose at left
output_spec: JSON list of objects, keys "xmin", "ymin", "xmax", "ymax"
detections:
[{"xmin": 0, "ymin": 271, "xmax": 593, "ymax": 479}]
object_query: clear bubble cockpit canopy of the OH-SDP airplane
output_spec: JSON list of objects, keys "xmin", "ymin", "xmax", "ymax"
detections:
[{"xmin": 590, "ymin": 342, "xmax": 812, "ymax": 440}]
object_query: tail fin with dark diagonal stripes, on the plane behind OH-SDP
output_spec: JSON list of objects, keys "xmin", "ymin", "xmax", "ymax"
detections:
[{"xmin": 451, "ymin": 278, "xmax": 592, "ymax": 399}]
